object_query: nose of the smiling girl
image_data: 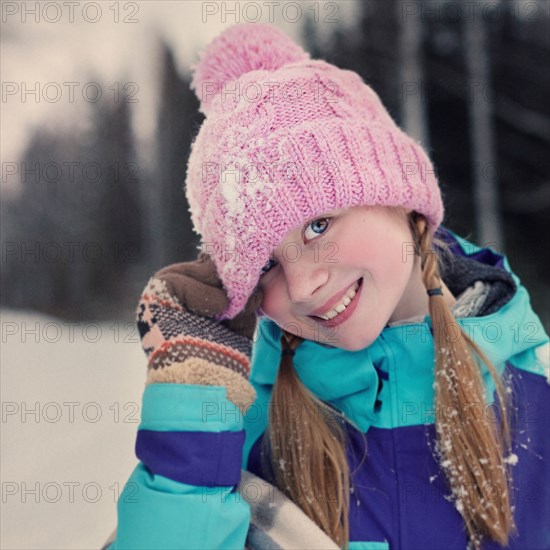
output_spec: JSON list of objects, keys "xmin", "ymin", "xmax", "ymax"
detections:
[{"xmin": 283, "ymin": 258, "xmax": 329, "ymax": 308}]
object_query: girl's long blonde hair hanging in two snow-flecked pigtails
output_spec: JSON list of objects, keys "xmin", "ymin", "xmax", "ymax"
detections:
[{"xmin": 263, "ymin": 212, "xmax": 516, "ymax": 549}]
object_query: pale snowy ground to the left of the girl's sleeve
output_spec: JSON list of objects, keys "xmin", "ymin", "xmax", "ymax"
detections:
[{"xmin": 0, "ymin": 310, "xmax": 146, "ymax": 550}]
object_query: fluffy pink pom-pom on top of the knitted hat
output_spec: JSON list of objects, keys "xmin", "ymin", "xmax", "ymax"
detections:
[{"xmin": 191, "ymin": 23, "xmax": 310, "ymax": 115}]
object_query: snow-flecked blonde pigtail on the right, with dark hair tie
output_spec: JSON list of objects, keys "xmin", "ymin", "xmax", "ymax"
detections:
[{"xmin": 411, "ymin": 213, "xmax": 516, "ymax": 549}]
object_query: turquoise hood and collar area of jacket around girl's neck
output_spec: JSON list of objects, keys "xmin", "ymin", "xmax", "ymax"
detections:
[{"xmin": 250, "ymin": 227, "xmax": 548, "ymax": 438}]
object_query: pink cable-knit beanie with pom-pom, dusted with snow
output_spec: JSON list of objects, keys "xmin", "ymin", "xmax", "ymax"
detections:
[{"xmin": 186, "ymin": 23, "xmax": 443, "ymax": 320}]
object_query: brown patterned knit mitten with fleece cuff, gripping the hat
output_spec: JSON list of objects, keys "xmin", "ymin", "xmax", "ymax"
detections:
[{"xmin": 136, "ymin": 252, "xmax": 263, "ymax": 411}]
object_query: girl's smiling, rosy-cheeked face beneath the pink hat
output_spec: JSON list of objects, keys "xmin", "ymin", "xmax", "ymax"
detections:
[{"xmin": 260, "ymin": 206, "xmax": 428, "ymax": 351}]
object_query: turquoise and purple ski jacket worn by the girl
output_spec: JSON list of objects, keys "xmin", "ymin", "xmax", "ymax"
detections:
[{"xmin": 104, "ymin": 227, "xmax": 550, "ymax": 550}]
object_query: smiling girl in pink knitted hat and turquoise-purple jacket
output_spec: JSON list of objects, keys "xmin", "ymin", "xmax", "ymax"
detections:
[{"xmin": 106, "ymin": 24, "xmax": 550, "ymax": 549}]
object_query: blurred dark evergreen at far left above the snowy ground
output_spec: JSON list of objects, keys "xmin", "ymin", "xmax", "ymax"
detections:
[{"xmin": 2, "ymin": 80, "xmax": 142, "ymax": 319}]
